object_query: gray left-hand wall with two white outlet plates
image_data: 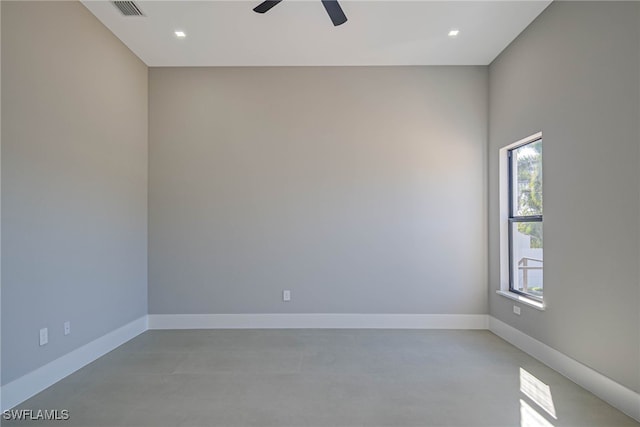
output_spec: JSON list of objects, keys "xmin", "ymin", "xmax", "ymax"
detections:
[{"xmin": 2, "ymin": 1, "xmax": 148, "ymax": 383}]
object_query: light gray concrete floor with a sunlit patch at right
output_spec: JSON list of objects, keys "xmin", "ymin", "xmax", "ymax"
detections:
[{"xmin": 3, "ymin": 330, "xmax": 640, "ymax": 427}]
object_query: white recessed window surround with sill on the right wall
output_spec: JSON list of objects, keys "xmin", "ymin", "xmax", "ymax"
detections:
[{"xmin": 497, "ymin": 132, "xmax": 546, "ymax": 311}]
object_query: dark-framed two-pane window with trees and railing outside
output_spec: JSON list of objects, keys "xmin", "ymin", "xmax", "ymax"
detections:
[{"xmin": 507, "ymin": 134, "xmax": 544, "ymax": 301}]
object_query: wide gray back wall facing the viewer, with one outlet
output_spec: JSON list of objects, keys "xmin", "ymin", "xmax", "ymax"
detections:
[{"xmin": 149, "ymin": 67, "xmax": 487, "ymax": 314}]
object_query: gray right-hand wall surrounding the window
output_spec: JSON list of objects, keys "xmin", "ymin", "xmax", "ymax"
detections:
[{"xmin": 489, "ymin": 2, "xmax": 640, "ymax": 391}]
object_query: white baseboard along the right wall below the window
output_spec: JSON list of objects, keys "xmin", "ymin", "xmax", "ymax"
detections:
[{"xmin": 489, "ymin": 316, "xmax": 640, "ymax": 421}]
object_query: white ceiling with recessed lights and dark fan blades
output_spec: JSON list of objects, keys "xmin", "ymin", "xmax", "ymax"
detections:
[{"xmin": 83, "ymin": 0, "xmax": 551, "ymax": 67}]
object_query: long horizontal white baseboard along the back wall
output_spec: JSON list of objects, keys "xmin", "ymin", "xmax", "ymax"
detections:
[{"xmin": 149, "ymin": 313, "xmax": 488, "ymax": 329}]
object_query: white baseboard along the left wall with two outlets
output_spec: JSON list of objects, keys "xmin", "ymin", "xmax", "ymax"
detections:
[{"xmin": 2, "ymin": 316, "xmax": 148, "ymax": 411}]
